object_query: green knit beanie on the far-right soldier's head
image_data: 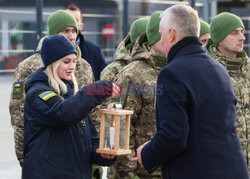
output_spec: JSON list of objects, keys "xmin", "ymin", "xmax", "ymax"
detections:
[{"xmin": 210, "ymin": 12, "xmax": 245, "ymax": 47}]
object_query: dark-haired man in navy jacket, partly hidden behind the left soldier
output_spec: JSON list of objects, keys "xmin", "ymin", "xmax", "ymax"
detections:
[{"xmin": 66, "ymin": 5, "xmax": 107, "ymax": 81}]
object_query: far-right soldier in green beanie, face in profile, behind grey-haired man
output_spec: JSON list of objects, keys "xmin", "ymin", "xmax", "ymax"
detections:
[{"xmin": 205, "ymin": 12, "xmax": 250, "ymax": 171}]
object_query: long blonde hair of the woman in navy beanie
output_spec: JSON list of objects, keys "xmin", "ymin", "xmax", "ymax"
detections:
[{"xmin": 45, "ymin": 59, "xmax": 78, "ymax": 95}]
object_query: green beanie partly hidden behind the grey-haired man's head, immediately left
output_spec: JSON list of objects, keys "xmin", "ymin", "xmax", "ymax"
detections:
[{"xmin": 146, "ymin": 11, "xmax": 163, "ymax": 45}]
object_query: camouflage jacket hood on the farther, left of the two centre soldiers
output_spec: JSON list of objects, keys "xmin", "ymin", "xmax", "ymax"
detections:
[{"xmin": 114, "ymin": 35, "xmax": 133, "ymax": 62}]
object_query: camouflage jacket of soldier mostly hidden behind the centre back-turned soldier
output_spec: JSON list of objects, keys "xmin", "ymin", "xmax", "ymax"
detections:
[{"xmin": 100, "ymin": 35, "xmax": 133, "ymax": 81}]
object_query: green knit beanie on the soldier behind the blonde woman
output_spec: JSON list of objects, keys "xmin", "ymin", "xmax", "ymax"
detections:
[{"xmin": 48, "ymin": 10, "xmax": 78, "ymax": 36}]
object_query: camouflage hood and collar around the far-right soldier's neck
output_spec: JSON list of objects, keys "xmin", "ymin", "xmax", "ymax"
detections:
[{"xmin": 204, "ymin": 39, "xmax": 248, "ymax": 71}]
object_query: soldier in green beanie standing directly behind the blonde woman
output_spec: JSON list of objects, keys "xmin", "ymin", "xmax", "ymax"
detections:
[{"xmin": 9, "ymin": 10, "xmax": 94, "ymax": 166}]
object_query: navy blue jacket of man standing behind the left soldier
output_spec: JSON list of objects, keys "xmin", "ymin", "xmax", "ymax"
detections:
[{"xmin": 78, "ymin": 33, "xmax": 107, "ymax": 81}]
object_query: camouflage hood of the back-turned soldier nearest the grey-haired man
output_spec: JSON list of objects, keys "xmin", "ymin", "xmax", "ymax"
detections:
[{"xmin": 131, "ymin": 33, "xmax": 167, "ymax": 70}]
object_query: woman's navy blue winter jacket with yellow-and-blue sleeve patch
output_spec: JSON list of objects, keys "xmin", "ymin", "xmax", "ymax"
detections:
[{"xmin": 23, "ymin": 69, "xmax": 115, "ymax": 179}]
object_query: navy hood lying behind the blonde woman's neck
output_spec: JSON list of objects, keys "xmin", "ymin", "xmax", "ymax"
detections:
[{"xmin": 25, "ymin": 68, "xmax": 49, "ymax": 93}]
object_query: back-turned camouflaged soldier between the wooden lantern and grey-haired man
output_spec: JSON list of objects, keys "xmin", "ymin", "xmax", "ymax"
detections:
[{"xmin": 111, "ymin": 11, "xmax": 167, "ymax": 178}]
